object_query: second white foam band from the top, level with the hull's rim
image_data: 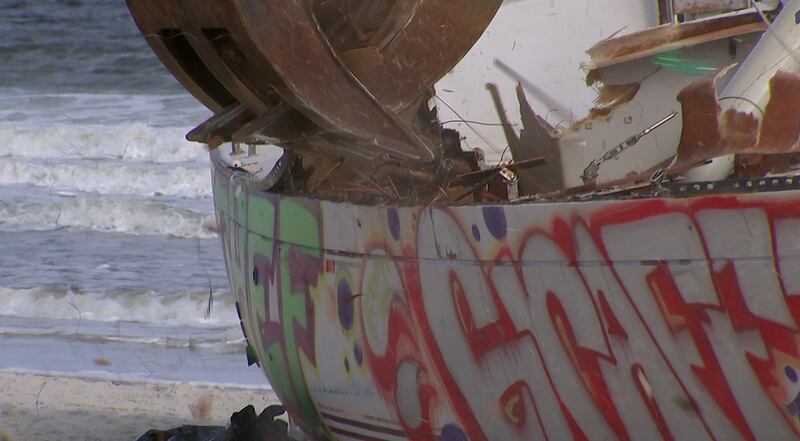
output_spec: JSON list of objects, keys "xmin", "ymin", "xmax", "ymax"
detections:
[{"xmin": 0, "ymin": 157, "xmax": 211, "ymax": 198}]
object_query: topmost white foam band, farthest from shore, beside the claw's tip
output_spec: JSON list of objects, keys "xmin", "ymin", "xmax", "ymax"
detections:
[{"xmin": 0, "ymin": 122, "xmax": 208, "ymax": 163}]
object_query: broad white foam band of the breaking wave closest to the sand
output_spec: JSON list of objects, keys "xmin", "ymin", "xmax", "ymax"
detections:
[{"xmin": 0, "ymin": 288, "xmax": 239, "ymax": 328}]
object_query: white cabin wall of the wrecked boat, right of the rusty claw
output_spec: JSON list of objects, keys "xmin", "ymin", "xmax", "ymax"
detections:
[{"xmin": 436, "ymin": 0, "xmax": 658, "ymax": 162}]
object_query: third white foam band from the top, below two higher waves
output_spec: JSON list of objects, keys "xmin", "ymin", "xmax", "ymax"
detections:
[{"xmin": 0, "ymin": 195, "xmax": 216, "ymax": 238}]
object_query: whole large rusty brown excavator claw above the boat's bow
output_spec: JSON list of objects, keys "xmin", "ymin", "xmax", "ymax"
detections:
[{"xmin": 128, "ymin": 0, "xmax": 502, "ymax": 164}]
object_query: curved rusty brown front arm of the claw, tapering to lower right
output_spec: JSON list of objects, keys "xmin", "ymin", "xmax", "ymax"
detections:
[{"xmin": 233, "ymin": 0, "xmax": 435, "ymax": 161}]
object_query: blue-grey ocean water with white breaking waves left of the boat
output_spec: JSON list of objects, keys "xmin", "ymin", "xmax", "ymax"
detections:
[{"xmin": 0, "ymin": 0, "xmax": 267, "ymax": 387}]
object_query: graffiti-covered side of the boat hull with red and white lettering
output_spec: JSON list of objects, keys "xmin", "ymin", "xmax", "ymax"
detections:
[{"xmin": 214, "ymin": 156, "xmax": 800, "ymax": 441}]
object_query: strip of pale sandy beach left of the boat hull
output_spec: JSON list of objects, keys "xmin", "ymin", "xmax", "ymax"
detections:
[{"xmin": 0, "ymin": 373, "xmax": 278, "ymax": 441}]
